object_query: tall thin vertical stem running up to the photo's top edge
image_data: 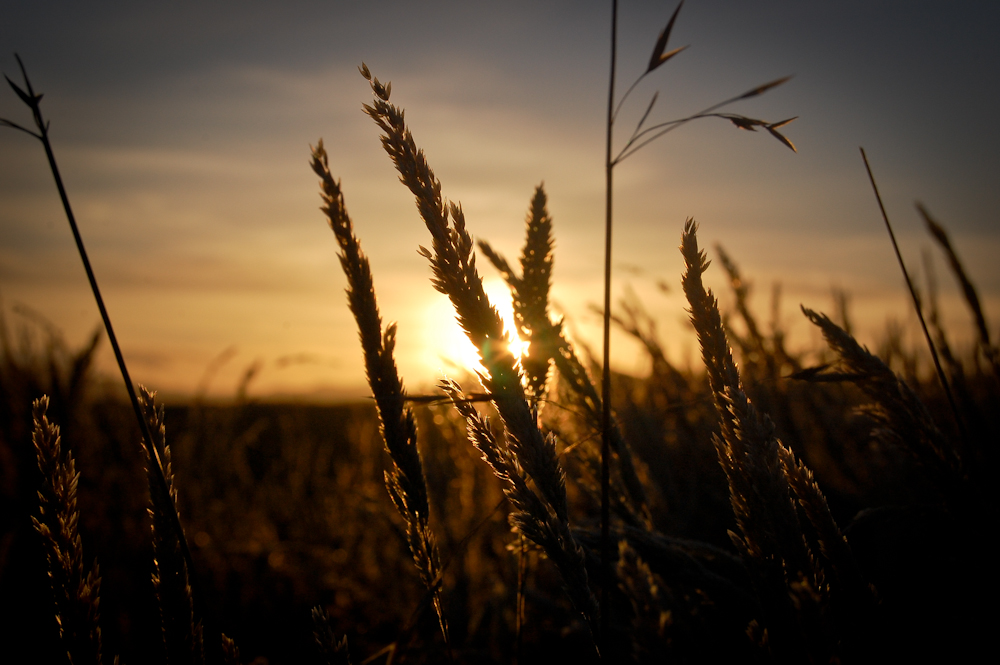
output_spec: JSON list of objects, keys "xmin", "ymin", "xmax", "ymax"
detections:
[{"xmin": 598, "ymin": 0, "xmax": 618, "ymax": 657}]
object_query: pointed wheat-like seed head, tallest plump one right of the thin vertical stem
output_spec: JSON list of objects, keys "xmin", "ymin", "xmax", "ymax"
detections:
[{"xmin": 681, "ymin": 219, "xmax": 842, "ymax": 657}]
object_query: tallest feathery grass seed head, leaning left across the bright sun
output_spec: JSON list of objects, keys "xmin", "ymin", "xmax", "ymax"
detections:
[{"xmin": 361, "ymin": 65, "xmax": 599, "ymax": 638}]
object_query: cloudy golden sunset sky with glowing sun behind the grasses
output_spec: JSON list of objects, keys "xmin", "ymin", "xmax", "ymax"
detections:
[{"xmin": 0, "ymin": 0, "xmax": 1000, "ymax": 399}]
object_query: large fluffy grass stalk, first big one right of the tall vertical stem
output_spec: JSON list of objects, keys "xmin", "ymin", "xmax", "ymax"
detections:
[{"xmin": 681, "ymin": 220, "xmax": 874, "ymax": 662}]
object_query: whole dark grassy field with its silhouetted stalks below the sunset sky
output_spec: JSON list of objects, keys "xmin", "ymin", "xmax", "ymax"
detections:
[{"xmin": 0, "ymin": 3, "xmax": 1000, "ymax": 664}]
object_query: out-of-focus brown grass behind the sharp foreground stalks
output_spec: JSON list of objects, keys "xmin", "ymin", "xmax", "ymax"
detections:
[{"xmin": 0, "ymin": 246, "xmax": 1000, "ymax": 663}]
